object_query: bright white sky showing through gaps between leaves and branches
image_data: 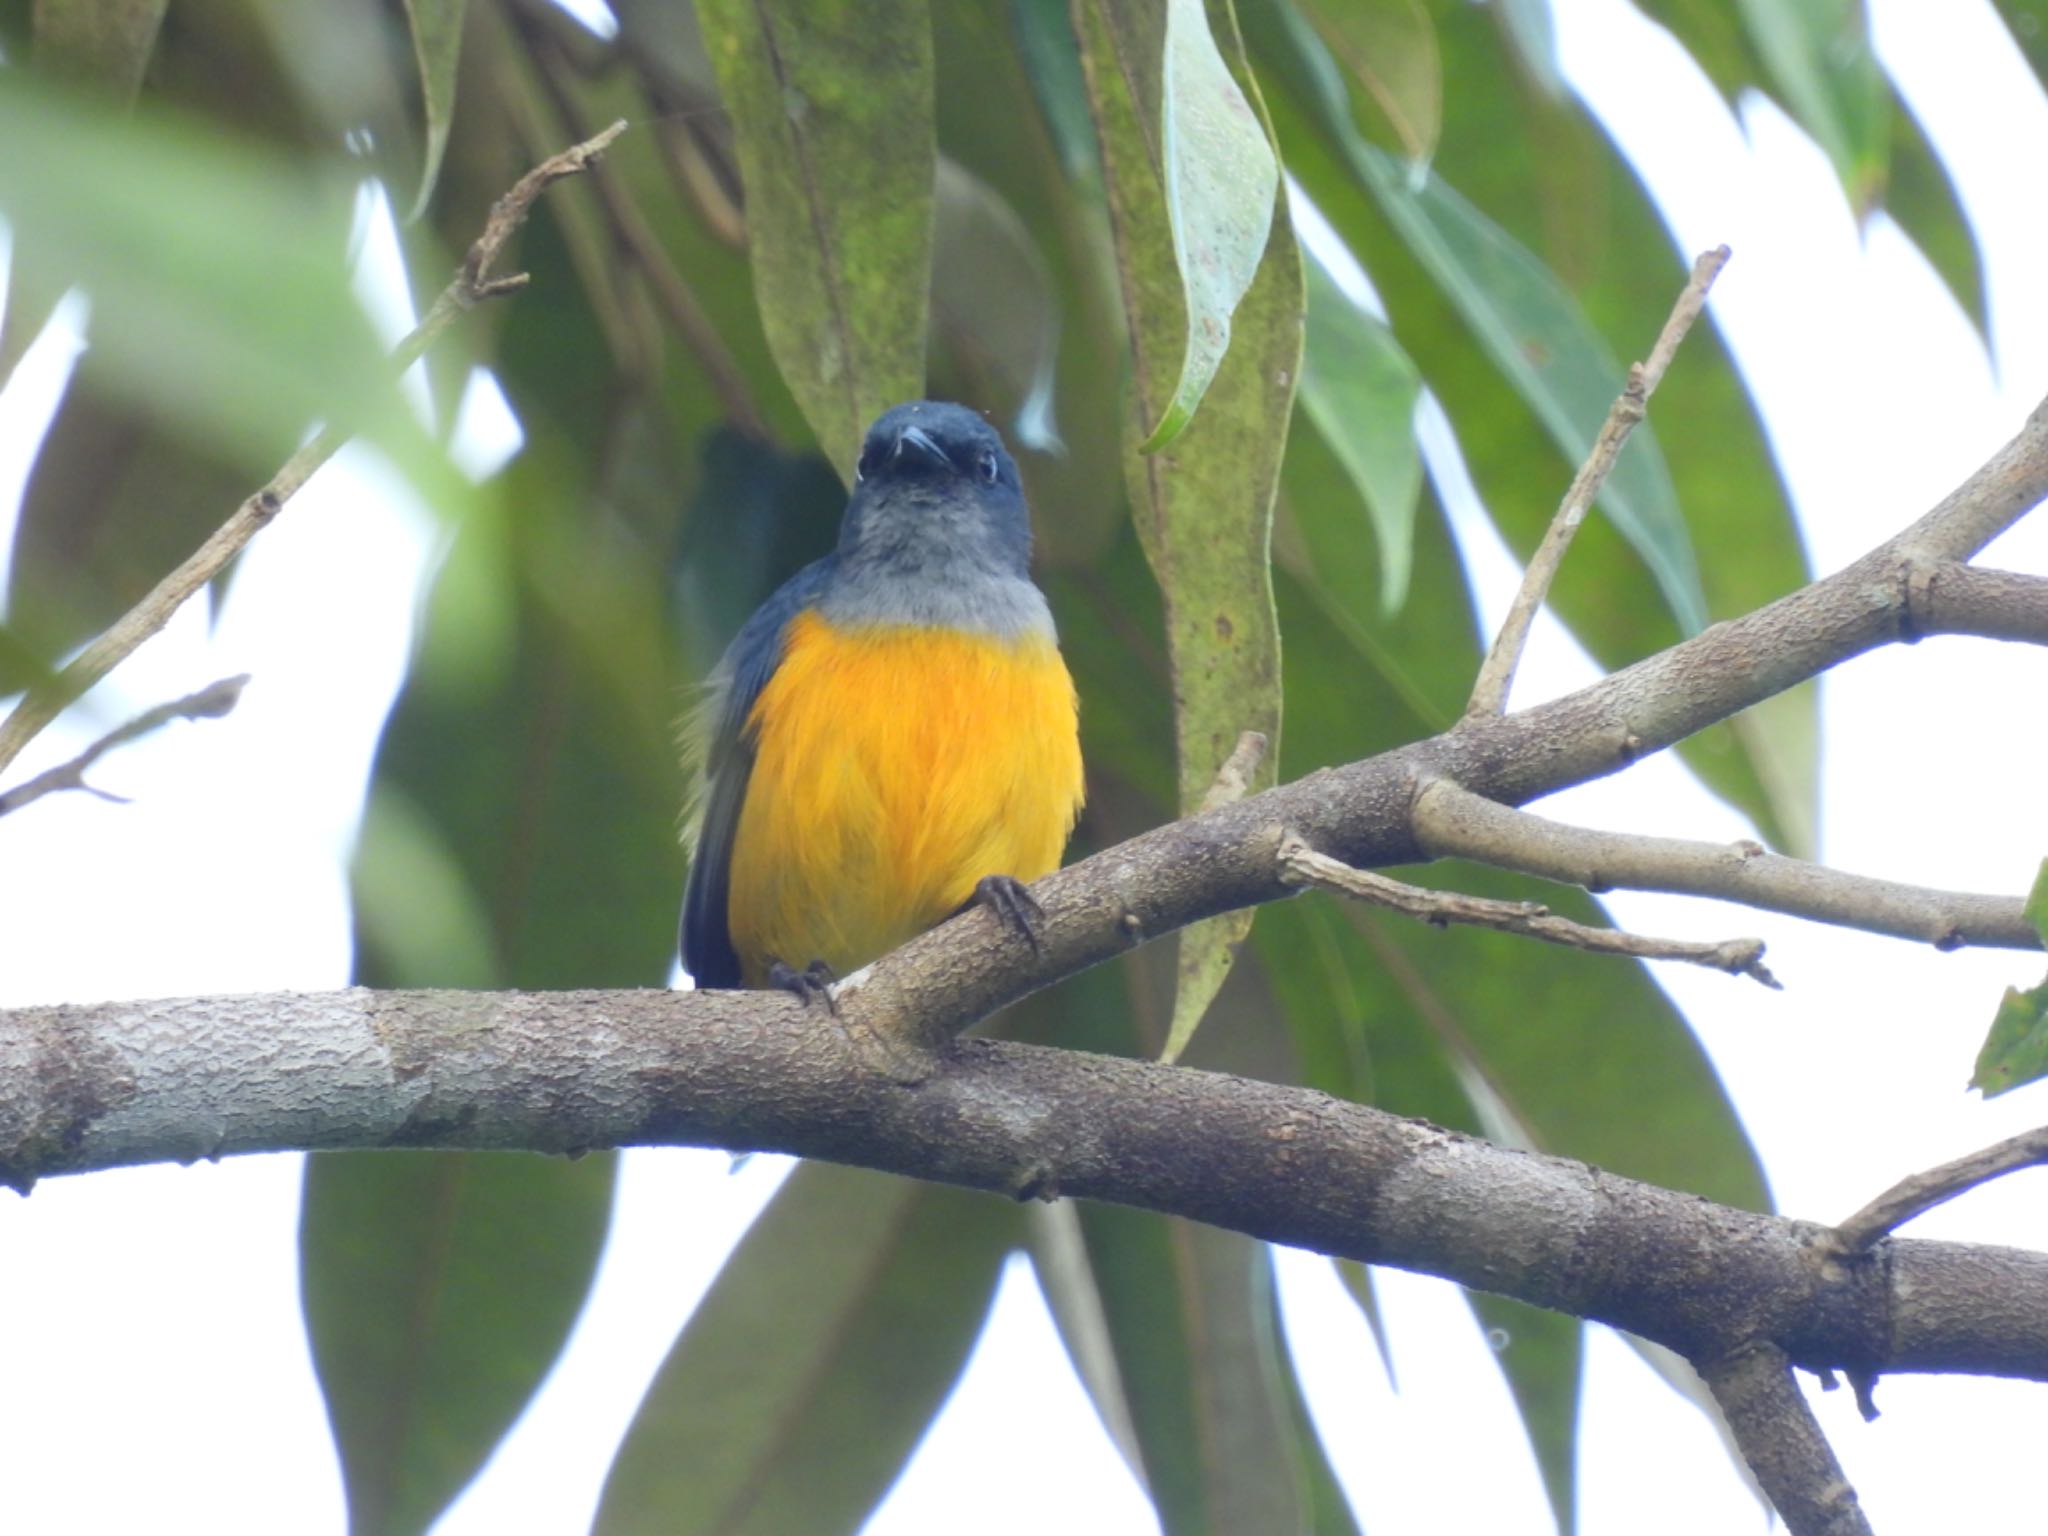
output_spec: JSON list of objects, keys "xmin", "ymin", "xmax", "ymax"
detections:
[{"xmin": 0, "ymin": 0, "xmax": 2048, "ymax": 1536}]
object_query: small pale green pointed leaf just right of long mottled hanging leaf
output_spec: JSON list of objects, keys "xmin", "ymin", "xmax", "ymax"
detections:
[{"xmin": 1300, "ymin": 256, "xmax": 1421, "ymax": 612}]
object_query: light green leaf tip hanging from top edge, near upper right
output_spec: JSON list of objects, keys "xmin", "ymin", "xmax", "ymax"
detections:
[{"xmin": 1739, "ymin": 0, "xmax": 1890, "ymax": 215}]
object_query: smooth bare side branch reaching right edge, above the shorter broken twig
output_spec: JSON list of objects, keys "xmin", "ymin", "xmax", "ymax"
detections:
[{"xmin": 1411, "ymin": 778, "xmax": 2042, "ymax": 950}]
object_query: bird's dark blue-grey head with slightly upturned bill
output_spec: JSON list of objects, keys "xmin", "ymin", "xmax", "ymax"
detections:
[{"xmin": 840, "ymin": 399, "xmax": 1030, "ymax": 582}]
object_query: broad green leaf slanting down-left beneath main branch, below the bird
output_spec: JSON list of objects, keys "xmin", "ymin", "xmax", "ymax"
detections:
[{"xmin": 596, "ymin": 1163, "xmax": 1022, "ymax": 1536}]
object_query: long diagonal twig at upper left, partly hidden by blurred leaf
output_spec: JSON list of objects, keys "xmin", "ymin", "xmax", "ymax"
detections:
[{"xmin": 0, "ymin": 121, "xmax": 627, "ymax": 782}]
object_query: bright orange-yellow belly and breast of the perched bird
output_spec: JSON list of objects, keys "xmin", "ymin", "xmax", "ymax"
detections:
[{"xmin": 727, "ymin": 612, "xmax": 1081, "ymax": 987}]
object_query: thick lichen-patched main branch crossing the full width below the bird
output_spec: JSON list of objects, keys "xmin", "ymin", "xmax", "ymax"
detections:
[{"xmin": 0, "ymin": 978, "xmax": 2048, "ymax": 1380}]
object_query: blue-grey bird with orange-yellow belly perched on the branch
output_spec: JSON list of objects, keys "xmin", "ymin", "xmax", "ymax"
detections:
[{"xmin": 680, "ymin": 399, "xmax": 1083, "ymax": 1006}]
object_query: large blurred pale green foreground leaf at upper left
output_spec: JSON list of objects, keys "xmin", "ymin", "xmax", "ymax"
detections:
[{"xmin": 0, "ymin": 72, "xmax": 463, "ymax": 505}]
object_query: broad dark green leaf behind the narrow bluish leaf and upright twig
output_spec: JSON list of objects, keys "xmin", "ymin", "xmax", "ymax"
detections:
[{"xmin": 1247, "ymin": 6, "xmax": 1817, "ymax": 852}]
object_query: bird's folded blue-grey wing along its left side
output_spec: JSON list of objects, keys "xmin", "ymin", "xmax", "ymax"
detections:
[{"xmin": 682, "ymin": 555, "xmax": 836, "ymax": 987}]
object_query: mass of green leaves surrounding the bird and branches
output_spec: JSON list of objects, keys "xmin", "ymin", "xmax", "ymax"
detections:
[{"xmin": 0, "ymin": 0, "xmax": 2048, "ymax": 1536}]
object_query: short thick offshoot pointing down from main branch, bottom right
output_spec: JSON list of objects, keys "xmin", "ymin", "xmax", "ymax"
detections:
[{"xmin": 1700, "ymin": 1341, "xmax": 1872, "ymax": 1536}]
